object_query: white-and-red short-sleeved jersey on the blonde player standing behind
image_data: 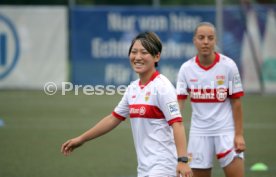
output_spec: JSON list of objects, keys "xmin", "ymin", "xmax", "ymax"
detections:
[{"xmin": 177, "ymin": 53, "xmax": 244, "ymax": 136}]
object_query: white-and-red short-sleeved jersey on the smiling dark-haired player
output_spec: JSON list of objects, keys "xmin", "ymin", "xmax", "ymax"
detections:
[{"xmin": 113, "ymin": 71, "xmax": 182, "ymax": 177}]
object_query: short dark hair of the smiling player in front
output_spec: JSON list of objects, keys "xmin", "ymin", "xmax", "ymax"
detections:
[{"xmin": 128, "ymin": 32, "xmax": 162, "ymax": 67}]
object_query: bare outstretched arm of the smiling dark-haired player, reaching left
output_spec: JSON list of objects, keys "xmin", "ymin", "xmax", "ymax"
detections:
[{"xmin": 61, "ymin": 114, "xmax": 122, "ymax": 156}]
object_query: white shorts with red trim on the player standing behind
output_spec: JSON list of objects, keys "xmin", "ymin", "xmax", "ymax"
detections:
[{"xmin": 188, "ymin": 134, "xmax": 244, "ymax": 169}]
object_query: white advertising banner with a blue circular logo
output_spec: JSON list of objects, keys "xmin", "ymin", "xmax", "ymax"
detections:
[{"xmin": 0, "ymin": 6, "xmax": 68, "ymax": 89}]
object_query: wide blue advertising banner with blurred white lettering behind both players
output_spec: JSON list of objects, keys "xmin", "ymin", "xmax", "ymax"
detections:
[{"xmin": 70, "ymin": 6, "xmax": 276, "ymax": 92}]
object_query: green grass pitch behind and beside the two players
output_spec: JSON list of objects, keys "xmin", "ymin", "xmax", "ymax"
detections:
[{"xmin": 0, "ymin": 90, "xmax": 276, "ymax": 177}]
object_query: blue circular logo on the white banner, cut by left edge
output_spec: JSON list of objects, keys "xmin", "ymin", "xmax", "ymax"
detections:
[{"xmin": 0, "ymin": 14, "xmax": 20, "ymax": 79}]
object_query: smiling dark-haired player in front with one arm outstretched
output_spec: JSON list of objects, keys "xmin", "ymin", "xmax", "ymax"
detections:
[{"xmin": 61, "ymin": 32, "xmax": 192, "ymax": 177}]
